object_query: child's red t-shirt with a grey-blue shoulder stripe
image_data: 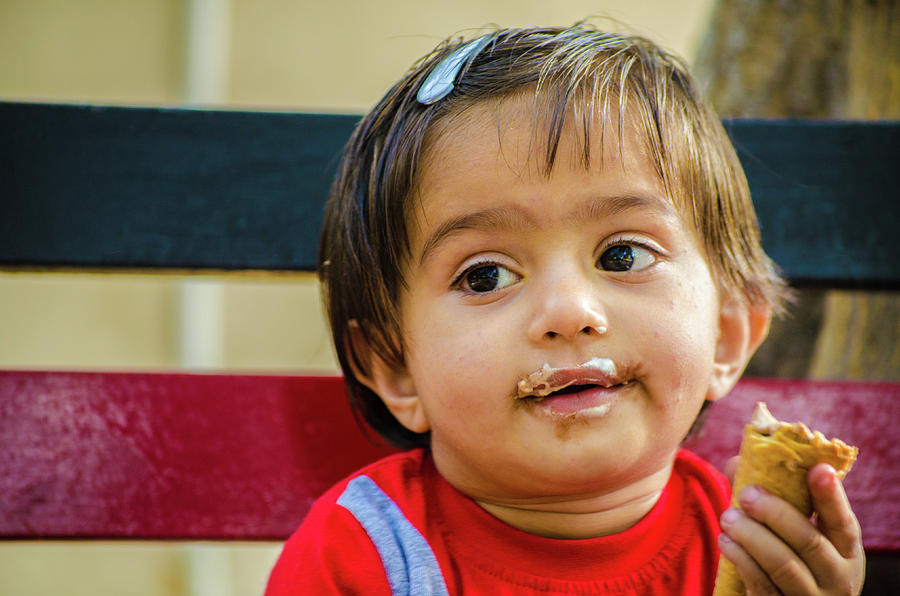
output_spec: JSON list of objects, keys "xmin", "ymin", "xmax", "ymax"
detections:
[{"xmin": 266, "ymin": 450, "xmax": 730, "ymax": 596}]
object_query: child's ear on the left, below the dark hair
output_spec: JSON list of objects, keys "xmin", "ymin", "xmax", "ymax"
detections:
[{"xmin": 348, "ymin": 320, "xmax": 430, "ymax": 433}]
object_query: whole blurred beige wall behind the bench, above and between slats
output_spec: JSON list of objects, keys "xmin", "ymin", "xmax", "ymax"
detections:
[{"xmin": 0, "ymin": 0, "xmax": 712, "ymax": 596}]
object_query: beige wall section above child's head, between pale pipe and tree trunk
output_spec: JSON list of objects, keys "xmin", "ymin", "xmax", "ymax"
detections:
[{"xmin": 229, "ymin": 0, "xmax": 711, "ymax": 112}]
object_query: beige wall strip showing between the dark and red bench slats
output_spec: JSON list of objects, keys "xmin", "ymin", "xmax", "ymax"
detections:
[{"xmin": 0, "ymin": 273, "xmax": 337, "ymax": 371}]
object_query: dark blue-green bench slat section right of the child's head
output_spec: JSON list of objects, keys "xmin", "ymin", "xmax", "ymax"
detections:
[{"xmin": 725, "ymin": 120, "xmax": 900, "ymax": 287}]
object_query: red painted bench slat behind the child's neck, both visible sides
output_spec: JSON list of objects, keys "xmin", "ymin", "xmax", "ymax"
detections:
[{"xmin": 0, "ymin": 371, "xmax": 900, "ymax": 550}]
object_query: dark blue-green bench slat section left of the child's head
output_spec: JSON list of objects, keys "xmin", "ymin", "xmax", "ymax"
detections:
[{"xmin": 0, "ymin": 104, "xmax": 358, "ymax": 269}]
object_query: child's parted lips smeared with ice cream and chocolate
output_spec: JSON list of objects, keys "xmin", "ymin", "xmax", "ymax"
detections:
[{"xmin": 516, "ymin": 358, "xmax": 622, "ymax": 416}]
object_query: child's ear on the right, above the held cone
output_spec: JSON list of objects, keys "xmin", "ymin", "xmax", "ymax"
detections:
[{"xmin": 706, "ymin": 297, "xmax": 772, "ymax": 401}]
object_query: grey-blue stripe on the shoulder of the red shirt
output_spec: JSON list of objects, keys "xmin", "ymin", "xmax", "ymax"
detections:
[{"xmin": 337, "ymin": 476, "xmax": 447, "ymax": 596}]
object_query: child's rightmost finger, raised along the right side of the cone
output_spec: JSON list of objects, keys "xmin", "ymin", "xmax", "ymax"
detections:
[{"xmin": 809, "ymin": 464, "xmax": 862, "ymax": 558}]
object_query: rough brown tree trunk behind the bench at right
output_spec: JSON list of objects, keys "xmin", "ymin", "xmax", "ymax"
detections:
[{"xmin": 695, "ymin": 0, "xmax": 900, "ymax": 380}]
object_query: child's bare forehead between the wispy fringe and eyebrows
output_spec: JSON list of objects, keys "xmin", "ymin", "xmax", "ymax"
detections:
[{"xmin": 407, "ymin": 99, "xmax": 680, "ymax": 239}]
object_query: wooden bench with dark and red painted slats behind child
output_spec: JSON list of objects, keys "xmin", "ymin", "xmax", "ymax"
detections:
[{"xmin": 0, "ymin": 103, "xmax": 900, "ymax": 594}]
